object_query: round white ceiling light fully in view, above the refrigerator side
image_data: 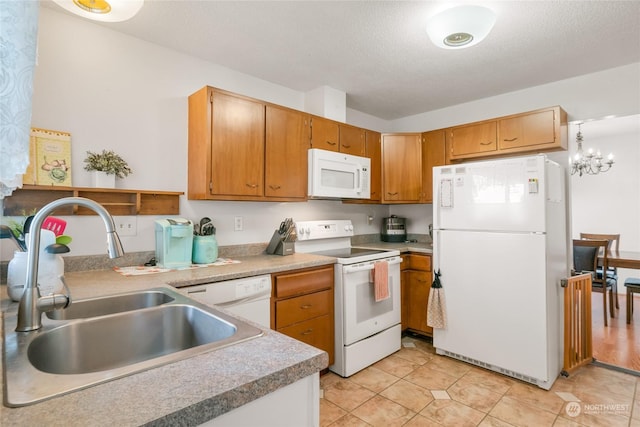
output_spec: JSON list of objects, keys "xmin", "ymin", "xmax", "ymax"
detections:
[{"xmin": 427, "ymin": 5, "xmax": 496, "ymax": 49}]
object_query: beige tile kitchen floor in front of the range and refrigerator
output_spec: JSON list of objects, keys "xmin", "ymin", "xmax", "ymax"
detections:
[{"xmin": 320, "ymin": 337, "xmax": 640, "ymax": 427}]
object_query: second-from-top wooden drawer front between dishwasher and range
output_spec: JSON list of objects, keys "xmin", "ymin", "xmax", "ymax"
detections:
[{"xmin": 276, "ymin": 291, "xmax": 333, "ymax": 329}]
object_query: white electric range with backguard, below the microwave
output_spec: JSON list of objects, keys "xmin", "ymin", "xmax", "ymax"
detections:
[{"xmin": 296, "ymin": 220, "xmax": 402, "ymax": 377}]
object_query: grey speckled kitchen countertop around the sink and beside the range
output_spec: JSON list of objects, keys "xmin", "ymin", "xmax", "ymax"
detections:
[{"xmin": 0, "ymin": 241, "xmax": 432, "ymax": 426}]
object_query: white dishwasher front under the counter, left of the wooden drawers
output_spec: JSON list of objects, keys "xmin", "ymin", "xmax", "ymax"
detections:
[{"xmin": 186, "ymin": 274, "xmax": 271, "ymax": 329}]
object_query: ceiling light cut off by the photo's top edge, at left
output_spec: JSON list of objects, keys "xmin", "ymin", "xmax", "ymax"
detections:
[{"xmin": 53, "ymin": 0, "xmax": 144, "ymax": 22}]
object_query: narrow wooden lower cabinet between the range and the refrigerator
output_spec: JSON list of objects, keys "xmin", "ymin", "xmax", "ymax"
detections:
[{"xmin": 401, "ymin": 253, "xmax": 433, "ymax": 336}]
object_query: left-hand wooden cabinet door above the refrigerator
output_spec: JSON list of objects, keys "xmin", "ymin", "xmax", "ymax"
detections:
[{"xmin": 451, "ymin": 121, "xmax": 498, "ymax": 159}]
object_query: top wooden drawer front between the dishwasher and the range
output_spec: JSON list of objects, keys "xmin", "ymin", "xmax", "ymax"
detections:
[{"xmin": 273, "ymin": 264, "xmax": 333, "ymax": 298}]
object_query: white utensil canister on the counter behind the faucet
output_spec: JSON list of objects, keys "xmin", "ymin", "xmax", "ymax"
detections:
[{"xmin": 7, "ymin": 251, "xmax": 64, "ymax": 301}]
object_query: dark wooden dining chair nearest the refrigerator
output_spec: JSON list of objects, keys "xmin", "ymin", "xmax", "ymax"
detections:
[{"xmin": 573, "ymin": 239, "xmax": 616, "ymax": 326}]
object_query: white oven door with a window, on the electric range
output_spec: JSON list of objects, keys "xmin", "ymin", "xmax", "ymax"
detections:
[{"xmin": 340, "ymin": 257, "xmax": 402, "ymax": 345}]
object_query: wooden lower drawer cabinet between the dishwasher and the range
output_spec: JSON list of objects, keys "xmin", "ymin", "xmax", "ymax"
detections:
[{"xmin": 271, "ymin": 265, "xmax": 335, "ymax": 365}]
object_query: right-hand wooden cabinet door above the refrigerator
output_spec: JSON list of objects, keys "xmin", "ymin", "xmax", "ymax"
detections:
[{"xmin": 498, "ymin": 110, "xmax": 556, "ymax": 151}]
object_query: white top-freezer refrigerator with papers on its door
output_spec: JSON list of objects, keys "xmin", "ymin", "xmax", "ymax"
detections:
[{"xmin": 433, "ymin": 155, "xmax": 569, "ymax": 390}]
